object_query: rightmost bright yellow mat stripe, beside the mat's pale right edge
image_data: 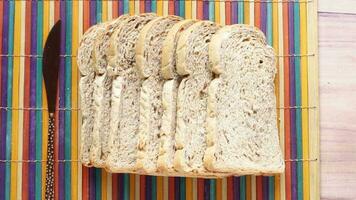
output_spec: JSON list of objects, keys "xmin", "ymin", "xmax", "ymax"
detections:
[{"xmin": 300, "ymin": 3, "xmax": 310, "ymax": 200}]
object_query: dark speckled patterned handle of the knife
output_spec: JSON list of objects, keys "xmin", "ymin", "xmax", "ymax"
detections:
[{"xmin": 45, "ymin": 113, "xmax": 54, "ymax": 200}]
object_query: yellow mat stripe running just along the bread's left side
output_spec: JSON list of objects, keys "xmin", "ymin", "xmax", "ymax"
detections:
[{"xmin": 71, "ymin": 1, "xmax": 79, "ymax": 199}]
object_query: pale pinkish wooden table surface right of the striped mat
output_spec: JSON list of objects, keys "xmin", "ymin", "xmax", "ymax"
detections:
[{"xmin": 318, "ymin": 0, "xmax": 356, "ymax": 199}]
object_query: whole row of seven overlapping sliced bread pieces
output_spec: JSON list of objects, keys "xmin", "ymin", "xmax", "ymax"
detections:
[{"xmin": 77, "ymin": 13, "xmax": 284, "ymax": 178}]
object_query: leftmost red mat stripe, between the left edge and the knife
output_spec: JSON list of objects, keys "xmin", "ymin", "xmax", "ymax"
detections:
[{"xmin": 22, "ymin": 1, "xmax": 32, "ymax": 199}]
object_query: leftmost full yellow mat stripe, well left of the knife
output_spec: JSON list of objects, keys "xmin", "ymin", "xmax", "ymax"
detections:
[{"xmin": 10, "ymin": 1, "xmax": 22, "ymax": 199}]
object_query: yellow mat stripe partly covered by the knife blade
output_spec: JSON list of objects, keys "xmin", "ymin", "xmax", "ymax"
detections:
[{"xmin": 41, "ymin": 1, "xmax": 52, "ymax": 199}]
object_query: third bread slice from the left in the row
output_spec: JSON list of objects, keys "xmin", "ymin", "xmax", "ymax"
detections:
[{"xmin": 105, "ymin": 13, "xmax": 156, "ymax": 172}]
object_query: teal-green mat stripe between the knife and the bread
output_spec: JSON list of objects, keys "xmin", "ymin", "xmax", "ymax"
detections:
[{"xmin": 64, "ymin": 1, "xmax": 73, "ymax": 199}]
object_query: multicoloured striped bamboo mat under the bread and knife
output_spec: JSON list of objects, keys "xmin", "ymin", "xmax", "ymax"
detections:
[{"xmin": 0, "ymin": 0, "xmax": 320, "ymax": 200}]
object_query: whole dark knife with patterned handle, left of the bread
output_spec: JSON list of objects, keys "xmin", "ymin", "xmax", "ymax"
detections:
[{"xmin": 42, "ymin": 20, "xmax": 61, "ymax": 199}]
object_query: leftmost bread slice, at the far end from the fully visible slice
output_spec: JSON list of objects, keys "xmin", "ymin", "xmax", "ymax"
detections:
[{"xmin": 77, "ymin": 23, "xmax": 107, "ymax": 166}]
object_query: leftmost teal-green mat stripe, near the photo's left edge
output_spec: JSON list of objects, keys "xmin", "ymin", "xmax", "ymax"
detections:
[{"xmin": 1, "ymin": 1, "xmax": 15, "ymax": 200}]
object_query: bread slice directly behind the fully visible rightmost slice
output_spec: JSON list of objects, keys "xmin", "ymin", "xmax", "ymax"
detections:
[{"xmin": 174, "ymin": 21, "xmax": 220, "ymax": 174}]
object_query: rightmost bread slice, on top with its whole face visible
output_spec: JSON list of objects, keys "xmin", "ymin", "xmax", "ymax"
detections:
[{"xmin": 204, "ymin": 25, "xmax": 284, "ymax": 175}]
